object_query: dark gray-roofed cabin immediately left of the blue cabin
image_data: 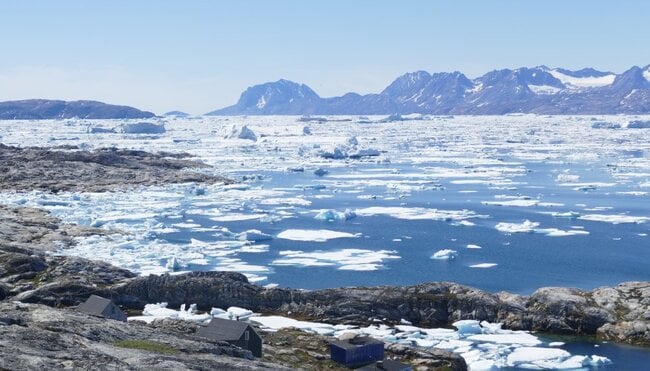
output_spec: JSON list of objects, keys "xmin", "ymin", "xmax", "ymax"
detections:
[{"xmin": 196, "ymin": 318, "xmax": 262, "ymax": 358}]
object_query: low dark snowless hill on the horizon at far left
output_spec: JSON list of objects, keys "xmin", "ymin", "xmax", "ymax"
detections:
[{"xmin": 0, "ymin": 99, "xmax": 155, "ymax": 120}]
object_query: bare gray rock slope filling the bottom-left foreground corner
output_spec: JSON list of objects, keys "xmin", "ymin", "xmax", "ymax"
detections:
[{"xmin": 0, "ymin": 301, "xmax": 288, "ymax": 370}]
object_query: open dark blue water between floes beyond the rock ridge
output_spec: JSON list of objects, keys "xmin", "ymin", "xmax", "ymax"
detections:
[{"xmin": 159, "ymin": 164, "xmax": 650, "ymax": 294}]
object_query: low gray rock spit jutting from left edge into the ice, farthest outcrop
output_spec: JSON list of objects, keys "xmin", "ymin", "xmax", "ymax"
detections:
[{"xmin": 0, "ymin": 144, "xmax": 229, "ymax": 192}]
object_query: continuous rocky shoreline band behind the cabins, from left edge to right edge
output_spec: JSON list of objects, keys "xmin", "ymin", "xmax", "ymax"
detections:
[{"xmin": 0, "ymin": 201, "xmax": 650, "ymax": 345}]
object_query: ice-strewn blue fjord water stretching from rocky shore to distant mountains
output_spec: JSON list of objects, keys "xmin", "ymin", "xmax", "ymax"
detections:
[{"xmin": 1, "ymin": 116, "xmax": 650, "ymax": 369}]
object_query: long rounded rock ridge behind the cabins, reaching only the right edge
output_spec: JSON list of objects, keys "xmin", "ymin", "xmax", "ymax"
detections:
[{"xmin": 110, "ymin": 272, "xmax": 650, "ymax": 345}]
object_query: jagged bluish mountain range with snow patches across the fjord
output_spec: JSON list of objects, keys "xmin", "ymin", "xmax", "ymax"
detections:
[{"xmin": 207, "ymin": 65, "xmax": 650, "ymax": 115}]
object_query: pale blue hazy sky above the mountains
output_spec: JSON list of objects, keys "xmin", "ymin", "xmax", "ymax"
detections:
[{"xmin": 0, "ymin": 0, "xmax": 650, "ymax": 114}]
